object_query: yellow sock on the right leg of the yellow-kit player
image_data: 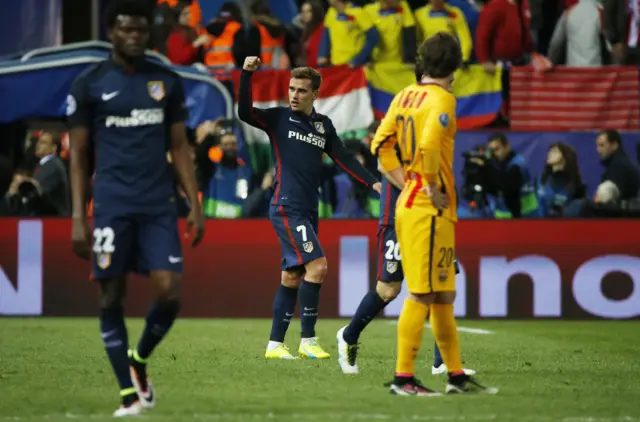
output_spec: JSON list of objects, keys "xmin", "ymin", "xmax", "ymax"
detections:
[{"xmin": 428, "ymin": 303, "xmax": 462, "ymax": 373}]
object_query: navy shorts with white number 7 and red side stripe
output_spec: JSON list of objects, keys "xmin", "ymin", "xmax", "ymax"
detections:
[{"xmin": 269, "ymin": 205, "xmax": 324, "ymax": 270}]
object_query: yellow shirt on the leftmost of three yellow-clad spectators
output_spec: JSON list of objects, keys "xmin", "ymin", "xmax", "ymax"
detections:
[{"xmin": 324, "ymin": 5, "xmax": 373, "ymax": 66}]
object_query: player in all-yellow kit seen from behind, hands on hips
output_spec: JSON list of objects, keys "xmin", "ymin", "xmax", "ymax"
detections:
[{"xmin": 372, "ymin": 32, "xmax": 497, "ymax": 396}]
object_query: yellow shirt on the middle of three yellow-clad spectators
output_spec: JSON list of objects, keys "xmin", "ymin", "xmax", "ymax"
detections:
[{"xmin": 364, "ymin": 0, "xmax": 416, "ymax": 63}]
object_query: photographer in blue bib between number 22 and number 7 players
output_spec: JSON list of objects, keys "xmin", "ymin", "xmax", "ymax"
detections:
[{"xmin": 196, "ymin": 121, "xmax": 251, "ymax": 218}]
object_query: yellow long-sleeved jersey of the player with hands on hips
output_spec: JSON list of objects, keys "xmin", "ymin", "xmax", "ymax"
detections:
[{"xmin": 371, "ymin": 83, "xmax": 458, "ymax": 221}]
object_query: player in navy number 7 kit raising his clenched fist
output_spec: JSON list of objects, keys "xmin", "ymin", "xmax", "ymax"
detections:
[{"xmin": 238, "ymin": 57, "xmax": 380, "ymax": 359}]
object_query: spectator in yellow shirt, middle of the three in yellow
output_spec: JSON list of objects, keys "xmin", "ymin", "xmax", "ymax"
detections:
[{"xmin": 365, "ymin": 0, "xmax": 417, "ymax": 64}]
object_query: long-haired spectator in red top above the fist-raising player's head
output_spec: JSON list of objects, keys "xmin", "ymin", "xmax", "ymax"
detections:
[{"xmin": 291, "ymin": 0, "xmax": 324, "ymax": 68}]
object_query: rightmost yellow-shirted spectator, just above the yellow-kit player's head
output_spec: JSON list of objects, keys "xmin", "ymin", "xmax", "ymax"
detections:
[{"xmin": 416, "ymin": 0, "xmax": 476, "ymax": 62}]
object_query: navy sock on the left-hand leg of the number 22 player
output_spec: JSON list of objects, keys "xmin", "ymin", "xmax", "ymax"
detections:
[{"xmin": 100, "ymin": 306, "xmax": 136, "ymax": 396}]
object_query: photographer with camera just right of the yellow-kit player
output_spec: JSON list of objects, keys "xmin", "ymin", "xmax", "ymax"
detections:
[{"xmin": 469, "ymin": 133, "xmax": 540, "ymax": 219}]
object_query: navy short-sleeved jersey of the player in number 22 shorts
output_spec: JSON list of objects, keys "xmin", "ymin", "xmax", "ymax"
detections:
[{"xmin": 68, "ymin": 60, "xmax": 184, "ymax": 213}]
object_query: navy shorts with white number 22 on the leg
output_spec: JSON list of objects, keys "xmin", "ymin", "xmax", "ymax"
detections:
[{"xmin": 92, "ymin": 212, "xmax": 182, "ymax": 280}]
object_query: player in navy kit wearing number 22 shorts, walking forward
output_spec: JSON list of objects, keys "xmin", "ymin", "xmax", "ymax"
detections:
[{"xmin": 67, "ymin": 0, "xmax": 204, "ymax": 417}]
